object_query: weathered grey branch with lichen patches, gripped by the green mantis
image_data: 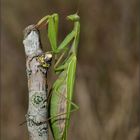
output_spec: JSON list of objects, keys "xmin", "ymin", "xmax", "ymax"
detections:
[{"xmin": 23, "ymin": 25, "xmax": 52, "ymax": 140}]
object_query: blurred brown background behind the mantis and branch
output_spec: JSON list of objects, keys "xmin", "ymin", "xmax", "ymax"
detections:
[{"xmin": 0, "ymin": 0, "xmax": 140, "ymax": 140}]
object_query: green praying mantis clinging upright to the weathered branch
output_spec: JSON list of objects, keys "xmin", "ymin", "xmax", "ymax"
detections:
[{"xmin": 37, "ymin": 14, "xmax": 80, "ymax": 140}]
